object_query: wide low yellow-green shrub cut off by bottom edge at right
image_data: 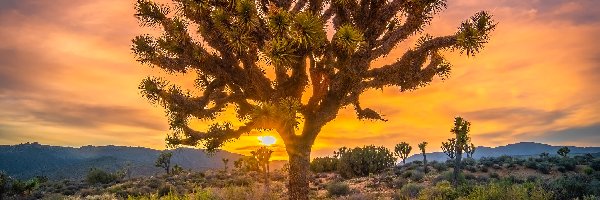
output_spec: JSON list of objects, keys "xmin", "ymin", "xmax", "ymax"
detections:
[{"xmin": 458, "ymin": 182, "xmax": 552, "ymax": 200}]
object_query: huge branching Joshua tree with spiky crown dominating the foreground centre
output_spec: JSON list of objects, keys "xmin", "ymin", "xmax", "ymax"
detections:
[{"xmin": 132, "ymin": 0, "xmax": 495, "ymax": 199}]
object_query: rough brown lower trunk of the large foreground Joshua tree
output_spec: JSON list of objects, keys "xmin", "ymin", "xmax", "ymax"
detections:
[{"xmin": 286, "ymin": 145, "xmax": 311, "ymax": 200}]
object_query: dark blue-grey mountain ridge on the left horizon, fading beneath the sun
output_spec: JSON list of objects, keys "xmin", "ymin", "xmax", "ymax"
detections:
[{"xmin": 0, "ymin": 143, "xmax": 248, "ymax": 180}]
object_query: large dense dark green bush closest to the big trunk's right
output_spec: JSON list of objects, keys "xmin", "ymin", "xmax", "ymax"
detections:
[{"xmin": 337, "ymin": 145, "xmax": 396, "ymax": 178}]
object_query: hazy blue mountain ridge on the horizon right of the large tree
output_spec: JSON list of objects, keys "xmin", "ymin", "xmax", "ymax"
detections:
[{"xmin": 406, "ymin": 142, "xmax": 600, "ymax": 162}]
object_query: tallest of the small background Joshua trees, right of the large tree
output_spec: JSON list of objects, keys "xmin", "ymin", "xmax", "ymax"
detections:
[{"xmin": 442, "ymin": 117, "xmax": 471, "ymax": 186}]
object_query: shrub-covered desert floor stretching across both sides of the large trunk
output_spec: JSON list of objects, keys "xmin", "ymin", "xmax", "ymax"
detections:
[{"xmin": 0, "ymin": 117, "xmax": 600, "ymax": 200}]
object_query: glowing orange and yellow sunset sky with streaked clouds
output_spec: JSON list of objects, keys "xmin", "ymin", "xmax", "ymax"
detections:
[{"xmin": 0, "ymin": 0, "xmax": 600, "ymax": 159}]
